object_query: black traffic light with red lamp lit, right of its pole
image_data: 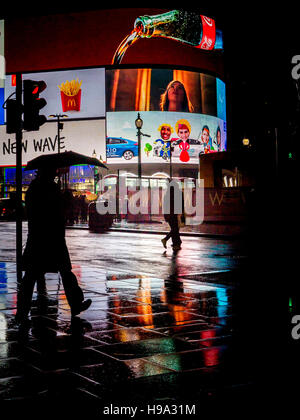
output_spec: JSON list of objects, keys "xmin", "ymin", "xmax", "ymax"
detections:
[{"xmin": 23, "ymin": 80, "xmax": 47, "ymax": 131}]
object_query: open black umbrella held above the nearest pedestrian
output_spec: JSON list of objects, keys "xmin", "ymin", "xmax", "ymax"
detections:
[{"xmin": 25, "ymin": 151, "xmax": 108, "ymax": 171}]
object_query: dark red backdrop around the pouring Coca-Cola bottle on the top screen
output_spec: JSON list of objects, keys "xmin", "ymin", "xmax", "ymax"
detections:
[{"xmin": 6, "ymin": 6, "xmax": 225, "ymax": 77}]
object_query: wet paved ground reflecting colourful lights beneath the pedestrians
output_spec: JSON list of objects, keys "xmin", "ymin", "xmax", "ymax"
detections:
[{"xmin": 0, "ymin": 223, "xmax": 270, "ymax": 418}]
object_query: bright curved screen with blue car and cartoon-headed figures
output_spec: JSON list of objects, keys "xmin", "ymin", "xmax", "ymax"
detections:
[{"xmin": 106, "ymin": 111, "xmax": 226, "ymax": 164}]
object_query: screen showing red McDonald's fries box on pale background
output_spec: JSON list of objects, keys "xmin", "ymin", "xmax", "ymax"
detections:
[{"xmin": 5, "ymin": 68, "xmax": 105, "ymax": 119}]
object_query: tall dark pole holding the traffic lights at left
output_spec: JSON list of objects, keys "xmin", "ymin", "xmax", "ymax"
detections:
[{"xmin": 16, "ymin": 73, "xmax": 23, "ymax": 282}]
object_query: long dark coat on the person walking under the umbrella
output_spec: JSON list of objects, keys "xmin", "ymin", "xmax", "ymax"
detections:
[{"xmin": 22, "ymin": 178, "xmax": 72, "ymax": 272}]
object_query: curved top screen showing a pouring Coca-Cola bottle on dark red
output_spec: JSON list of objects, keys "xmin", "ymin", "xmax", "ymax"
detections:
[{"xmin": 6, "ymin": 7, "xmax": 224, "ymax": 74}]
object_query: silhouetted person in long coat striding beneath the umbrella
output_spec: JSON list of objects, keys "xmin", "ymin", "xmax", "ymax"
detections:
[{"xmin": 16, "ymin": 168, "xmax": 91, "ymax": 321}]
